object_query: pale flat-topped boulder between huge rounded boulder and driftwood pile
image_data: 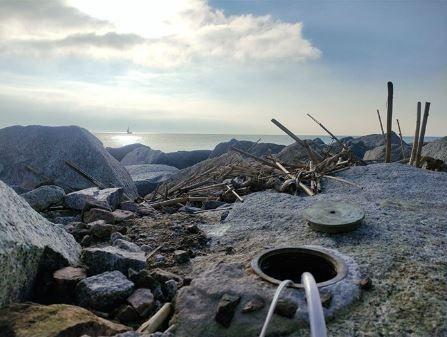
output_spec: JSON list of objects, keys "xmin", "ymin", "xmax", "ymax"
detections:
[{"xmin": 126, "ymin": 164, "xmax": 179, "ymax": 197}]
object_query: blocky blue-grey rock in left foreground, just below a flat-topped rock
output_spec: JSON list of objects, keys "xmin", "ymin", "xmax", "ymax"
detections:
[{"xmin": 76, "ymin": 270, "xmax": 134, "ymax": 311}]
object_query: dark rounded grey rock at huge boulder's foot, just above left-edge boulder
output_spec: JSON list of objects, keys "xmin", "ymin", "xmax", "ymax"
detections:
[{"xmin": 21, "ymin": 185, "xmax": 65, "ymax": 211}]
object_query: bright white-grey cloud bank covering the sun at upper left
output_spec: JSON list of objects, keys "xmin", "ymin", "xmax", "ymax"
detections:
[{"xmin": 0, "ymin": 0, "xmax": 321, "ymax": 69}]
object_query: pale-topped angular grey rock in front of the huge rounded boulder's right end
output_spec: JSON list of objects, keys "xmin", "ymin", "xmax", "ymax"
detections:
[{"xmin": 64, "ymin": 187, "xmax": 123, "ymax": 211}]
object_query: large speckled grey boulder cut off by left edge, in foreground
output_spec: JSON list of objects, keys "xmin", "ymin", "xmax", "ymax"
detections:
[{"xmin": 0, "ymin": 181, "xmax": 80, "ymax": 307}]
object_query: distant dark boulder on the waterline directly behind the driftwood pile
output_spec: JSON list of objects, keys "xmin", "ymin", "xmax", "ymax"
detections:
[{"xmin": 209, "ymin": 138, "xmax": 285, "ymax": 158}]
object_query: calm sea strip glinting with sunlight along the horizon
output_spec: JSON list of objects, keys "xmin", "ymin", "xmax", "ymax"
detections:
[{"xmin": 95, "ymin": 132, "xmax": 439, "ymax": 152}]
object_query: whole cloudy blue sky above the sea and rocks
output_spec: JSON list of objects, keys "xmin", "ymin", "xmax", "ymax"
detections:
[{"xmin": 0, "ymin": 0, "xmax": 447, "ymax": 136}]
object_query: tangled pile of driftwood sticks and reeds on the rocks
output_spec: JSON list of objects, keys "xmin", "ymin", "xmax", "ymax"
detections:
[{"xmin": 145, "ymin": 115, "xmax": 364, "ymax": 208}]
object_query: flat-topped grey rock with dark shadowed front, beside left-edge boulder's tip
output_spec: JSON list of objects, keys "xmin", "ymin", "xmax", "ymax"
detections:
[{"xmin": 82, "ymin": 246, "xmax": 146, "ymax": 275}]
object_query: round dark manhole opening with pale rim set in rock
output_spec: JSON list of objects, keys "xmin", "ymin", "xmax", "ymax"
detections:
[{"xmin": 251, "ymin": 247, "xmax": 347, "ymax": 288}]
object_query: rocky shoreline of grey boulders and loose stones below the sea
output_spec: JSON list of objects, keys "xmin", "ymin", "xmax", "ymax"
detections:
[{"xmin": 0, "ymin": 126, "xmax": 447, "ymax": 337}]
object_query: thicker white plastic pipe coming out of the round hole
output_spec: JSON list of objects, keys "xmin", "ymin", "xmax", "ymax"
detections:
[{"xmin": 301, "ymin": 272, "xmax": 327, "ymax": 337}]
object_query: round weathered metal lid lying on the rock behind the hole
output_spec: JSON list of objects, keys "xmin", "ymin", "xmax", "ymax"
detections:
[{"xmin": 303, "ymin": 201, "xmax": 365, "ymax": 233}]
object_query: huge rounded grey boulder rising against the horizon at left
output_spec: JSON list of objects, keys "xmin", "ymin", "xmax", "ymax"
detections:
[{"xmin": 0, "ymin": 125, "xmax": 138, "ymax": 198}]
